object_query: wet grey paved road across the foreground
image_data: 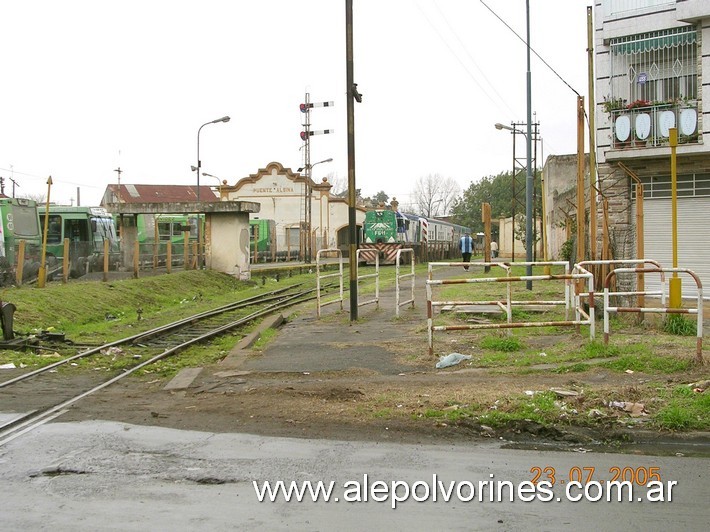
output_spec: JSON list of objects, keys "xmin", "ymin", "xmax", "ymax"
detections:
[{"xmin": 0, "ymin": 422, "xmax": 710, "ymax": 531}]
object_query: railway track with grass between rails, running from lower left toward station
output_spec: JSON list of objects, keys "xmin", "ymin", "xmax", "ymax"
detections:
[{"xmin": 0, "ymin": 285, "xmax": 315, "ymax": 446}]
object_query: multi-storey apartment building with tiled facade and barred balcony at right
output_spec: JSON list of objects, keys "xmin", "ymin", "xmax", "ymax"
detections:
[{"xmin": 594, "ymin": 0, "xmax": 710, "ymax": 296}]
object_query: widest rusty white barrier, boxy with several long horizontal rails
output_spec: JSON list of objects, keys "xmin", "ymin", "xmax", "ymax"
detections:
[{"xmin": 426, "ymin": 261, "xmax": 594, "ymax": 356}]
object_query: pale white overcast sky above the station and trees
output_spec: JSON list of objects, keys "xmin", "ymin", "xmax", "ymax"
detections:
[{"xmin": 0, "ymin": 0, "xmax": 591, "ymax": 210}]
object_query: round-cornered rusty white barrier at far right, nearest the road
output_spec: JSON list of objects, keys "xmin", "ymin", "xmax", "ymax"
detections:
[{"xmin": 604, "ymin": 268, "xmax": 703, "ymax": 364}]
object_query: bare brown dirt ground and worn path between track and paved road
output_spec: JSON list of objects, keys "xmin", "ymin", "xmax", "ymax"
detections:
[{"xmin": 47, "ymin": 284, "xmax": 710, "ymax": 447}]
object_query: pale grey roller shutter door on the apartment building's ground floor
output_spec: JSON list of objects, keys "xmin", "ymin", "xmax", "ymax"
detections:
[{"xmin": 633, "ymin": 197, "xmax": 710, "ymax": 298}]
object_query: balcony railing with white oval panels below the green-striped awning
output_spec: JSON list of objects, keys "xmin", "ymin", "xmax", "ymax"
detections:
[{"xmin": 609, "ymin": 100, "xmax": 702, "ymax": 150}]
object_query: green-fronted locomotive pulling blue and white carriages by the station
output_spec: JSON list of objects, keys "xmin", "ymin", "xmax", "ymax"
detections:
[{"xmin": 359, "ymin": 209, "xmax": 471, "ymax": 264}]
